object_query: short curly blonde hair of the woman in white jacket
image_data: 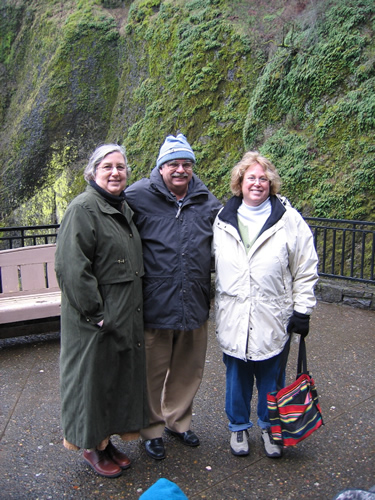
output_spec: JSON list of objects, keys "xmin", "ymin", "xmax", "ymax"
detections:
[{"xmin": 230, "ymin": 151, "xmax": 281, "ymax": 196}]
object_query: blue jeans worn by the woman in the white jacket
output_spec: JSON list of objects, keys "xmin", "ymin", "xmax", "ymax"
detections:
[{"xmin": 223, "ymin": 353, "xmax": 285, "ymax": 431}]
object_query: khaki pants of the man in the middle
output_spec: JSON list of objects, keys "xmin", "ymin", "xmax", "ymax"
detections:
[{"xmin": 141, "ymin": 322, "xmax": 208, "ymax": 439}]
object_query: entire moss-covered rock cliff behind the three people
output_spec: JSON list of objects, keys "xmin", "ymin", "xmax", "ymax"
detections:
[{"xmin": 0, "ymin": 0, "xmax": 375, "ymax": 225}]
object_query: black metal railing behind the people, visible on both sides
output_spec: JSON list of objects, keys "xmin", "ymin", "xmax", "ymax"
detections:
[{"xmin": 0, "ymin": 217, "xmax": 375, "ymax": 285}]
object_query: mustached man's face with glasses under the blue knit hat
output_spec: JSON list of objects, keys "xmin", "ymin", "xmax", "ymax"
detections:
[{"xmin": 160, "ymin": 158, "xmax": 194, "ymax": 198}]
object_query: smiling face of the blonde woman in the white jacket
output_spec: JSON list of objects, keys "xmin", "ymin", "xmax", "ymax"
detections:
[{"xmin": 241, "ymin": 163, "xmax": 270, "ymax": 207}]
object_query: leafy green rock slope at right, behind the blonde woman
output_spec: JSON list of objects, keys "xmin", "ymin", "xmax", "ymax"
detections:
[{"xmin": 244, "ymin": 2, "xmax": 375, "ymax": 220}]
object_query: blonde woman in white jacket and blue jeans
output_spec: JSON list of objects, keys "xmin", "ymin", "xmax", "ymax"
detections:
[{"xmin": 213, "ymin": 152, "xmax": 318, "ymax": 458}]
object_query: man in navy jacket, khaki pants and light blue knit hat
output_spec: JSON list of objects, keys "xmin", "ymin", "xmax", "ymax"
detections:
[{"xmin": 125, "ymin": 134, "xmax": 221, "ymax": 460}]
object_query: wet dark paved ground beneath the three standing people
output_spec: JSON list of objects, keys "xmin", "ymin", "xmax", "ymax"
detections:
[{"xmin": 0, "ymin": 302, "xmax": 375, "ymax": 500}]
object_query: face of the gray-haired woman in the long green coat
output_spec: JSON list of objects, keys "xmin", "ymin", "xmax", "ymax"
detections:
[{"xmin": 95, "ymin": 151, "xmax": 127, "ymax": 196}]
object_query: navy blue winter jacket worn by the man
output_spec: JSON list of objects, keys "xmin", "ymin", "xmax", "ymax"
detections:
[{"xmin": 125, "ymin": 167, "xmax": 221, "ymax": 330}]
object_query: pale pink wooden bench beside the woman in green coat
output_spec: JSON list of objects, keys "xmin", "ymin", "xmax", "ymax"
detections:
[{"xmin": 0, "ymin": 244, "xmax": 61, "ymax": 338}]
